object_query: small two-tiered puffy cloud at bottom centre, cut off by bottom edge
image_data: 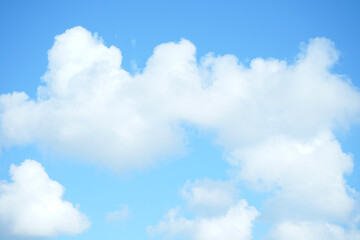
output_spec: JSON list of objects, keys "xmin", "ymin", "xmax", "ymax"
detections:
[{"xmin": 148, "ymin": 180, "xmax": 259, "ymax": 240}]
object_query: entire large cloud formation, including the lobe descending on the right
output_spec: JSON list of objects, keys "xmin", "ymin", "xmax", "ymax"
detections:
[{"xmin": 0, "ymin": 27, "xmax": 360, "ymax": 238}]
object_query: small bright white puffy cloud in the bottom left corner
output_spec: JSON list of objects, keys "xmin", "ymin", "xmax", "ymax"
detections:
[{"xmin": 0, "ymin": 160, "xmax": 90, "ymax": 239}]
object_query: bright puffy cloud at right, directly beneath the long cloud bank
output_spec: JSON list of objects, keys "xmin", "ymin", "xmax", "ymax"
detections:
[{"xmin": 230, "ymin": 133, "xmax": 355, "ymax": 222}]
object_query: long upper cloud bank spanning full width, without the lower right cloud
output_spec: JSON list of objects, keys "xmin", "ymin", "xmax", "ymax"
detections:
[{"xmin": 0, "ymin": 27, "xmax": 360, "ymax": 169}]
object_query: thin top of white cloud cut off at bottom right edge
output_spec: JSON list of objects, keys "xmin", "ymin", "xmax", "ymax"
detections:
[{"xmin": 269, "ymin": 221, "xmax": 360, "ymax": 240}]
